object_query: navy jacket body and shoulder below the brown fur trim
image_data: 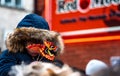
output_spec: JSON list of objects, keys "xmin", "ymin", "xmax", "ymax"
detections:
[{"xmin": 0, "ymin": 50, "xmax": 33, "ymax": 76}]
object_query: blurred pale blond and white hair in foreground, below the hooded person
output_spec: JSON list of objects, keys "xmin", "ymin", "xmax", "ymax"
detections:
[{"xmin": 9, "ymin": 62, "xmax": 83, "ymax": 76}]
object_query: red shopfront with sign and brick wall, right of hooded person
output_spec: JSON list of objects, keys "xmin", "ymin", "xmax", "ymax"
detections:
[{"xmin": 36, "ymin": 0, "xmax": 120, "ymax": 69}]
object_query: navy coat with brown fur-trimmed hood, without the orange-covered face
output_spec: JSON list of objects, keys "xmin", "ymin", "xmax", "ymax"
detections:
[{"xmin": 0, "ymin": 14, "xmax": 63, "ymax": 76}]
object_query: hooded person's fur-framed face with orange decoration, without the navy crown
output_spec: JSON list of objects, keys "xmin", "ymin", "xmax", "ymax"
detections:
[{"xmin": 6, "ymin": 27, "xmax": 64, "ymax": 60}]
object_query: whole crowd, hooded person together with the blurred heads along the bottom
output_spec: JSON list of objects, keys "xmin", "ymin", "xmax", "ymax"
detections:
[{"xmin": 0, "ymin": 14, "xmax": 120, "ymax": 76}]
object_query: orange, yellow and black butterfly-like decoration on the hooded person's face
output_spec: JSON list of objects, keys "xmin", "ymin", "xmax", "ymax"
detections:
[{"xmin": 26, "ymin": 41, "xmax": 57, "ymax": 61}]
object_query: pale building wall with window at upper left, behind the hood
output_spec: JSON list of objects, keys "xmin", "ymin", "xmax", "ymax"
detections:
[{"xmin": 0, "ymin": 0, "xmax": 34, "ymax": 50}]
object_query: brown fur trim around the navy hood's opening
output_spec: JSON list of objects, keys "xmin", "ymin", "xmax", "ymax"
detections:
[{"xmin": 6, "ymin": 27, "xmax": 64, "ymax": 54}]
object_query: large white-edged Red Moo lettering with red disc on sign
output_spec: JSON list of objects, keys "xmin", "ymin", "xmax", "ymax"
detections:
[{"xmin": 56, "ymin": 0, "xmax": 120, "ymax": 14}]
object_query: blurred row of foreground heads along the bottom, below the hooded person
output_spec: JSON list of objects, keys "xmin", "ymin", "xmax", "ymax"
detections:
[{"xmin": 9, "ymin": 57, "xmax": 120, "ymax": 76}]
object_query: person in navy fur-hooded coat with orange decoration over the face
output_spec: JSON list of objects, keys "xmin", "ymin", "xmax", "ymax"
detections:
[{"xmin": 0, "ymin": 14, "xmax": 64, "ymax": 76}]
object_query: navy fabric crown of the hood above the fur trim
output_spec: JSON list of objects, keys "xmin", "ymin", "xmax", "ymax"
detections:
[{"xmin": 17, "ymin": 14, "xmax": 49, "ymax": 30}]
